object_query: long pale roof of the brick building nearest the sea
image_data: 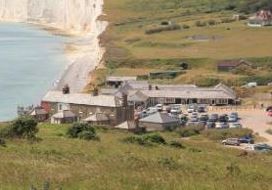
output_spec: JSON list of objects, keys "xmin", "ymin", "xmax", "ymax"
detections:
[{"xmin": 42, "ymin": 91, "xmax": 121, "ymax": 107}]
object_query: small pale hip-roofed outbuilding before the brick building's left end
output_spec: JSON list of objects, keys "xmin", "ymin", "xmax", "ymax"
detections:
[{"xmin": 51, "ymin": 110, "xmax": 78, "ymax": 124}]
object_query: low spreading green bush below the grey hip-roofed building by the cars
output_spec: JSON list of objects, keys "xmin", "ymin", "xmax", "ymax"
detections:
[{"xmin": 123, "ymin": 134, "xmax": 166, "ymax": 146}]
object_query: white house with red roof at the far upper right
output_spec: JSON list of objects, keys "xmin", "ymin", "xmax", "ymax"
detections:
[{"xmin": 248, "ymin": 10, "xmax": 272, "ymax": 27}]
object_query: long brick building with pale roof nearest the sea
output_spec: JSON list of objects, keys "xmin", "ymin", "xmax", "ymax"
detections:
[{"xmin": 41, "ymin": 91, "xmax": 134, "ymax": 126}]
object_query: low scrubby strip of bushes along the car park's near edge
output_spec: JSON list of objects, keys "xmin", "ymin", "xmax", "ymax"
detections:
[{"xmin": 203, "ymin": 129, "xmax": 253, "ymax": 140}]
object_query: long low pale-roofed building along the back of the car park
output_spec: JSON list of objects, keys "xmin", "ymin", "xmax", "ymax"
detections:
[{"xmin": 101, "ymin": 81, "xmax": 237, "ymax": 108}]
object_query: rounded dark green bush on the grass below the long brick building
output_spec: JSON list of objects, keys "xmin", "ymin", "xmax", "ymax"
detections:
[{"xmin": 67, "ymin": 123, "xmax": 99, "ymax": 140}]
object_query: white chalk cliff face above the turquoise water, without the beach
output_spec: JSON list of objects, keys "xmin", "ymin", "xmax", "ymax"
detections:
[{"xmin": 0, "ymin": 0, "xmax": 103, "ymax": 31}]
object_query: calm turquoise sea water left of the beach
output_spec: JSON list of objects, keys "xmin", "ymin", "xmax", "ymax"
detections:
[{"xmin": 0, "ymin": 23, "xmax": 68, "ymax": 121}]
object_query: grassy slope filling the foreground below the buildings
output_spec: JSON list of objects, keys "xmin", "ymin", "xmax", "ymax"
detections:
[{"xmin": 0, "ymin": 125, "xmax": 272, "ymax": 190}]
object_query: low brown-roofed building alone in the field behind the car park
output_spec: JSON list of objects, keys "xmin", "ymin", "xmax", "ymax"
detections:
[{"xmin": 217, "ymin": 60, "xmax": 252, "ymax": 71}]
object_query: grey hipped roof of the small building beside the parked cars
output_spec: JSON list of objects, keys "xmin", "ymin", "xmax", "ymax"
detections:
[{"xmin": 140, "ymin": 112, "xmax": 178, "ymax": 124}]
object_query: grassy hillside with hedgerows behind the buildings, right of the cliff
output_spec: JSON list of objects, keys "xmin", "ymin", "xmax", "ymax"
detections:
[{"xmin": 89, "ymin": 0, "xmax": 272, "ymax": 89}]
